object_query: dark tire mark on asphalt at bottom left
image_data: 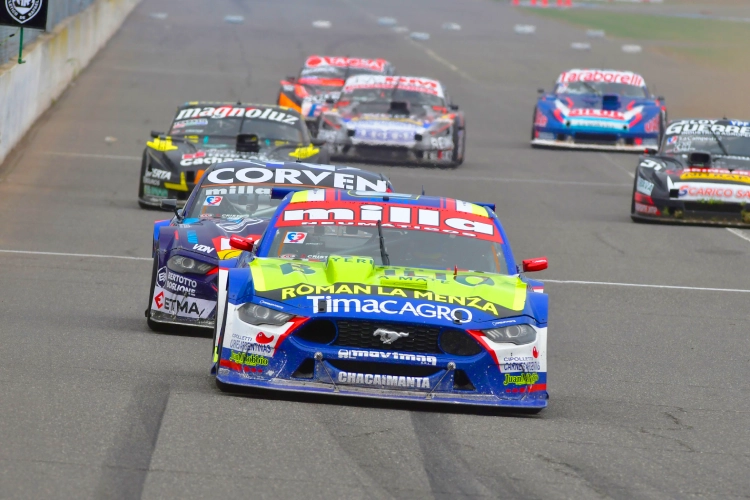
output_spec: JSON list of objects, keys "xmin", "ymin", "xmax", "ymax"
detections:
[{"xmin": 94, "ymin": 382, "xmax": 170, "ymax": 499}]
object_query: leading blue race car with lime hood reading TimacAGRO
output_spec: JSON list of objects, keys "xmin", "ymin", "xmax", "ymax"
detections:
[{"xmin": 213, "ymin": 189, "xmax": 548, "ymax": 412}]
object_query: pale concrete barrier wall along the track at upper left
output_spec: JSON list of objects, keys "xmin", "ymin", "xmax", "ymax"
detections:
[{"xmin": 0, "ymin": 0, "xmax": 140, "ymax": 163}]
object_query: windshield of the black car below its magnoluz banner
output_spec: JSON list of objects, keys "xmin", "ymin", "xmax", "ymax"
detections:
[{"xmin": 170, "ymin": 117, "xmax": 308, "ymax": 143}]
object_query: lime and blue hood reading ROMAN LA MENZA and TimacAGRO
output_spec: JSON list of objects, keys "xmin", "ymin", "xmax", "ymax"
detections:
[{"xmin": 244, "ymin": 256, "xmax": 546, "ymax": 326}]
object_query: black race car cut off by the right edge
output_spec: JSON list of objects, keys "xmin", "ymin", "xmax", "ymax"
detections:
[{"xmin": 630, "ymin": 119, "xmax": 750, "ymax": 226}]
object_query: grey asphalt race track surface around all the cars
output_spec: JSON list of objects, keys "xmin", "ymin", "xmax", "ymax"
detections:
[{"xmin": 0, "ymin": 0, "xmax": 750, "ymax": 499}]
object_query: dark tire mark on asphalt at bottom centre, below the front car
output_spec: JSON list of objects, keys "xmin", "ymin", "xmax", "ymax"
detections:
[{"xmin": 411, "ymin": 412, "xmax": 528, "ymax": 499}]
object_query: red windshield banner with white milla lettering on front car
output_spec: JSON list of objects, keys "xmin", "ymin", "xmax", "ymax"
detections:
[{"xmin": 276, "ymin": 202, "xmax": 501, "ymax": 243}]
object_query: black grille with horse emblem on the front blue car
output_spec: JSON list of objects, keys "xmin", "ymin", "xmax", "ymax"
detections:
[{"xmin": 333, "ymin": 320, "xmax": 442, "ymax": 354}]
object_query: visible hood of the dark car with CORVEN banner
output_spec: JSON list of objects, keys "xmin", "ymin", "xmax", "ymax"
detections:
[{"xmin": 167, "ymin": 217, "xmax": 269, "ymax": 260}]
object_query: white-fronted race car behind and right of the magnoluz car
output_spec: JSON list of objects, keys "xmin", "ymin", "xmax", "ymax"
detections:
[{"xmin": 318, "ymin": 75, "xmax": 466, "ymax": 166}]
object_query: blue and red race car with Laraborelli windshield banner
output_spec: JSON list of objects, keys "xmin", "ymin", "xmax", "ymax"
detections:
[{"xmin": 531, "ymin": 69, "xmax": 667, "ymax": 152}]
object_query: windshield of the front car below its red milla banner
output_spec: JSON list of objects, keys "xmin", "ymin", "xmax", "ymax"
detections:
[{"xmin": 268, "ymin": 225, "xmax": 508, "ymax": 274}]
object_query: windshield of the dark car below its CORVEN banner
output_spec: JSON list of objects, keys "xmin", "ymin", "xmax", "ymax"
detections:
[{"xmin": 186, "ymin": 184, "xmax": 281, "ymax": 219}]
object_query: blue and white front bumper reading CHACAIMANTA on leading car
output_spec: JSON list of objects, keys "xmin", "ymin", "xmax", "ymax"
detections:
[{"xmin": 213, "ymin": 310, "xmax": 548, "ymax": 409}]
